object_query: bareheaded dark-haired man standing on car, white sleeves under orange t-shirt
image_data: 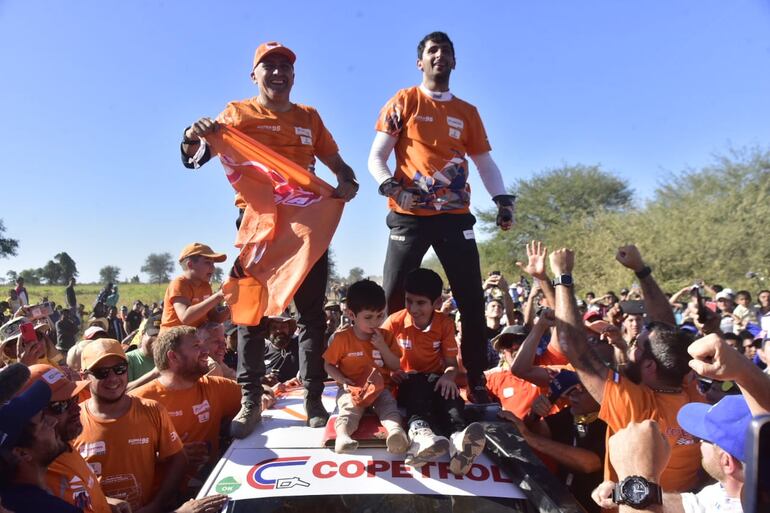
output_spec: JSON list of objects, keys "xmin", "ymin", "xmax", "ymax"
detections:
[{"xmin": 369, "ymin": 32, "xmax": 514, "ymax": 402}]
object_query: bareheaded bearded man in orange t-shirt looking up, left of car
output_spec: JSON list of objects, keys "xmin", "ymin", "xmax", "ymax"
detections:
[{"xmin": 131, "ymin": 326, "xmax": 240, "ymax": 494}]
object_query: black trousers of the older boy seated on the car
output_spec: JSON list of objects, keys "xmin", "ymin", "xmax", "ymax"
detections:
[{"xmin": 398, "ymin": 374, "xmax": 466, "ymax": 436}]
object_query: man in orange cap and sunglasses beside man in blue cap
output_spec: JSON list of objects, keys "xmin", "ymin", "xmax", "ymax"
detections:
[{"xmin": 20, "ymin": 364, "xmax": 114, "ymax": 513}]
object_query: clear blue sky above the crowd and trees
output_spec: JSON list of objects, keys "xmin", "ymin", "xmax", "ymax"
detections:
[{"xmin": 0, "ymin": 0, "xmax": 770, "ymax": 281}]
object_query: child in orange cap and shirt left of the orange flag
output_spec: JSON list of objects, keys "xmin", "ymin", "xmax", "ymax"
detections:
[{"xmin": 160, "ymin": 242, "xmax": 229, "ymax": 333}]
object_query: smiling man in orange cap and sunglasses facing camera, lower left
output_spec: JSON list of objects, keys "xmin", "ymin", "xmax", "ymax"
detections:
[{"xmin": 72, "ymin": 338, "xmax": 185, "ymax": 513}]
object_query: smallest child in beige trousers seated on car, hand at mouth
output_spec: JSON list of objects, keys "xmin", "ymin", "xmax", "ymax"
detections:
[{"xmin": 323, "ymin": 280, "xmax": 408, "ymax": 454}]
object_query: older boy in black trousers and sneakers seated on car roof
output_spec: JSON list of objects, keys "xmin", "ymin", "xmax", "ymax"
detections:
[{"xmin": 383, "ymin": 269, "xmax": 486, "ymax": 476}]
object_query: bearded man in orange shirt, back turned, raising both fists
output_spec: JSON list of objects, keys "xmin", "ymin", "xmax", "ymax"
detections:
[{"xmin": 551, "ymin": 245, "xmax": 702, "ymax": 492}]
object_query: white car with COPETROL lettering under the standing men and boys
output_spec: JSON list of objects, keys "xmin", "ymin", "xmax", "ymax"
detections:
[{"xmin": 199, "ymin": 384, "xmax": 583, "ymax": 513}]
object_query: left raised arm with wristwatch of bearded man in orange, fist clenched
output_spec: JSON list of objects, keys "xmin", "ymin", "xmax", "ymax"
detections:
[{"xmin": 551, "ymin": 248, "xmax": 608, "ymax": 403}]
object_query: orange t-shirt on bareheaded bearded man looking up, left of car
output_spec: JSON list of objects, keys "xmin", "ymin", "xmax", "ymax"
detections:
[{"xmin": 131, "ymin": 376, "xmax": 241, "ymax": 463}]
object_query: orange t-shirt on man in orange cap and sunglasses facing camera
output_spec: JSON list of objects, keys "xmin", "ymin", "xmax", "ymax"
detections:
[{"xmin": 72, "ymin": 397, "xmax": 182, "ymax": 511}]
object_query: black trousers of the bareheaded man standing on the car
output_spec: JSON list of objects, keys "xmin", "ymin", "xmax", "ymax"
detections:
[{"xmin": 384, "ymin": 212, "xmax": 487, "ymax": 378}]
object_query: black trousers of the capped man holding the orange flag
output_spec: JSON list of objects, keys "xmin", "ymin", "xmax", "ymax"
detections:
[{"xmin": 235, "ymin": 210, "xmax": 329, "ymax": 400}]
